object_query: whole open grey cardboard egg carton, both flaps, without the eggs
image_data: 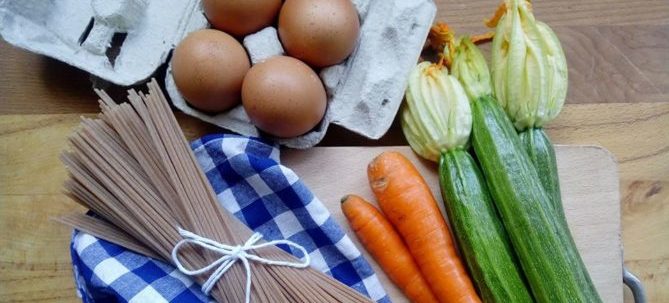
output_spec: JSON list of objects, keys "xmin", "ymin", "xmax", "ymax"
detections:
[{"xmin": 0, "ymin": 0, "xmax": 436, "ymax": 148}]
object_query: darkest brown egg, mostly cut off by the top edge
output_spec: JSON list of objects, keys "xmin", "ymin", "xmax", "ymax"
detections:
[{"xmin": 202, "ymin": 0, "xmax": 281, "ymax": 37}]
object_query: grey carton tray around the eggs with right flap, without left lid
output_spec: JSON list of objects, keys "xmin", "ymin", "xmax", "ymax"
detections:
[{"xmin": 165, "ymin": 0, "xmax": 436, "ymax": 148}]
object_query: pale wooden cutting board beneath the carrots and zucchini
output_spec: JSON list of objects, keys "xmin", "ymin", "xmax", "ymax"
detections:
[{"xmin": 281, "ymin": 146, "xmax": 623, "ymax": 302}]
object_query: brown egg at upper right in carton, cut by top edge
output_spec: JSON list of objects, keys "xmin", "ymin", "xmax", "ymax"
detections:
[{"xmin": 279, "ymin": 0, "xmax": 360, "ymax": 67}]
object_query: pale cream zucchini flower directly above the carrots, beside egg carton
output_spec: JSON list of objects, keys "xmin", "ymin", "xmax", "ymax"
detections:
[{"xmin": 402, "ymin": 62, "xmax": 472, "ymax": 162}]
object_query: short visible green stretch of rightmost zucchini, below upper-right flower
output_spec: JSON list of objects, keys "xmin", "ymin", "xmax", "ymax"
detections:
[{"xmin": 518, "ymin": 128, "xmax": 564, "ymax": 217}]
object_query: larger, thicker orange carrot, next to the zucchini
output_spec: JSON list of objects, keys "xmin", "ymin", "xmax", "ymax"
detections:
[{"xmin": 367, "ymin": 152, "xmax": 481, "ymax": 302}]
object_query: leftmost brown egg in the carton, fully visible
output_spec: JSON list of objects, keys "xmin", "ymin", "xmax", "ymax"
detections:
[{"xmin": 172, "ymin": 29, "xmax": 251, "ymax": 112}]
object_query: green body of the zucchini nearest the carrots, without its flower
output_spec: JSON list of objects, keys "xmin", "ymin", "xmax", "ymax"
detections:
[{"xmin": 439, "ymin": 149, "xmax": 534, "ymax": 303}]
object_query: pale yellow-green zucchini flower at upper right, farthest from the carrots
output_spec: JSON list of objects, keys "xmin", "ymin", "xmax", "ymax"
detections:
[{"xmin": 489, "ymin": 0, "xmax": 567, "ymax": 131}]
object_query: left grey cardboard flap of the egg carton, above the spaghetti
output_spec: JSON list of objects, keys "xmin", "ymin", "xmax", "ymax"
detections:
[{"xmin": 0, "ymin": 0, "xmax": 207, "ymax": 86}]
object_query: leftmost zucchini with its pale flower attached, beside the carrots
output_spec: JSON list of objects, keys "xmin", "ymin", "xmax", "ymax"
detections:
[{"xmin": 402, "ymin": 62, "xmax": 533, "ymax": 302}]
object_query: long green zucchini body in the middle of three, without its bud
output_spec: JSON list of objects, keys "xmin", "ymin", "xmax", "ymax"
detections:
[{"xmin": 471, "ymin": 96, "xmax": 601, "ymax": 302}]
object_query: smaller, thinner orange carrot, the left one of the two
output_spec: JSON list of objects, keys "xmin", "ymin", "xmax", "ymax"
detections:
[{"xmin": 341, "ymin": 195, "xmax": 437, "ymax": 303}]
